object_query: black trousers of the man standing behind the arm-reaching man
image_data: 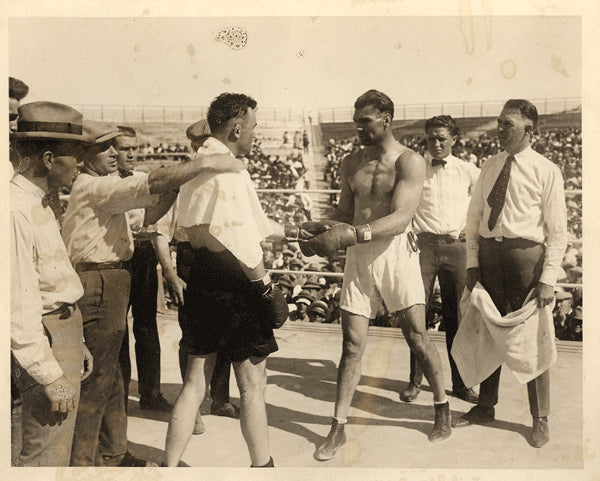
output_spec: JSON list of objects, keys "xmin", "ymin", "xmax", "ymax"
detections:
[{"xmin": 119, "ymin": 241, "xmax": 160, "ymax": 408}]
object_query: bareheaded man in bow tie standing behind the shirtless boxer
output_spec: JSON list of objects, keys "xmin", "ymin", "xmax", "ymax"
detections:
[{"xmin": 400, "ymin": 115, "xmax": 479, "ymax": 403}]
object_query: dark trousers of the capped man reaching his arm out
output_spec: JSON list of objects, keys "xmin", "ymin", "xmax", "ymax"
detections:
[{"xmin": 71, "ymin": 269, "xmax": 130, "ymax": 466}]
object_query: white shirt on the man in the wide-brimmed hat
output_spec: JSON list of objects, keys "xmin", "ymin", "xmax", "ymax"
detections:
[{"xmin": 9, "ymin": 174, "xmax": 83, "ymax": 385}]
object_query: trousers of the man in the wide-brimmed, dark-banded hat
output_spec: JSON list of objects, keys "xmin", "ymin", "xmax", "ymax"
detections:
[{"xmin": 13, "ymin": 309, "xmax": 83, "ymax": 467}]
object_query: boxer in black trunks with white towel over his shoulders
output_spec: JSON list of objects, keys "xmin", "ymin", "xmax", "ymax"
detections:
[{"xmin": 164, "ymin": 93, "xmax": 288, "ymax": 467}]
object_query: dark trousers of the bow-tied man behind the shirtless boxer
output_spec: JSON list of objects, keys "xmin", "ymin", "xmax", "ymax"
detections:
[{"xmin": 410, "ymin": 233, "xmax": 466, "ymax": 390}]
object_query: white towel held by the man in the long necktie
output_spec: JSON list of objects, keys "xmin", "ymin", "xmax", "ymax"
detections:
[{"xmin": 452, "ymin": 283, "xmax": 557, "ymax": 387}]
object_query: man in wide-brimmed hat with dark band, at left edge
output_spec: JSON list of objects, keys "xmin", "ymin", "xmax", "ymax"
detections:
[{"xmin": 9, "ymin": 102, "xmax": 93, "ymax": 466}]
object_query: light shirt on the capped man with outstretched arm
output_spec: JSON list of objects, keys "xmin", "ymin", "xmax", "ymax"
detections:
[{"xmin": 63, "ymin": 173, "xmax": 159, "ymax": 265}]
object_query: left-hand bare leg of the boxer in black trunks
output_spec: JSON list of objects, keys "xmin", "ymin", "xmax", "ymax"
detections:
[{"xmin": 164, "ymin": 352, "xmax": 217, "ymax": 466}]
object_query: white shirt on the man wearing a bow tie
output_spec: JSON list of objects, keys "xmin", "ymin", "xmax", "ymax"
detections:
[{"xmin": 413, "ymin": 153, "xmax": 479, "ymax": 239}]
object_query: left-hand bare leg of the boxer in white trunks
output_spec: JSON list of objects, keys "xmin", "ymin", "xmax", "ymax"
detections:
[{"xmin": 335, "ymin": 311, "xmax": 369, "ymax": 419}]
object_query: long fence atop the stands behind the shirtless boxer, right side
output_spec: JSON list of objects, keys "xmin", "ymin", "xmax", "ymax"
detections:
[{"xmin": 318, "ymin": 98, "xmax": 581, "ymax": 123}]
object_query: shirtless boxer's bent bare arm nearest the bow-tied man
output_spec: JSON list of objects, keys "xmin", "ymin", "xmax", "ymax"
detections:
[{"xmin": 369, "ymin": 151, "xmax": 426, "ymax": 239}]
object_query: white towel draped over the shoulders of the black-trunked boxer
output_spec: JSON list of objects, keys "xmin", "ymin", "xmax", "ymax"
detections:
[{"xmin": 177, "ymin": 137, "xmax": 273, "ymax": 268}]
